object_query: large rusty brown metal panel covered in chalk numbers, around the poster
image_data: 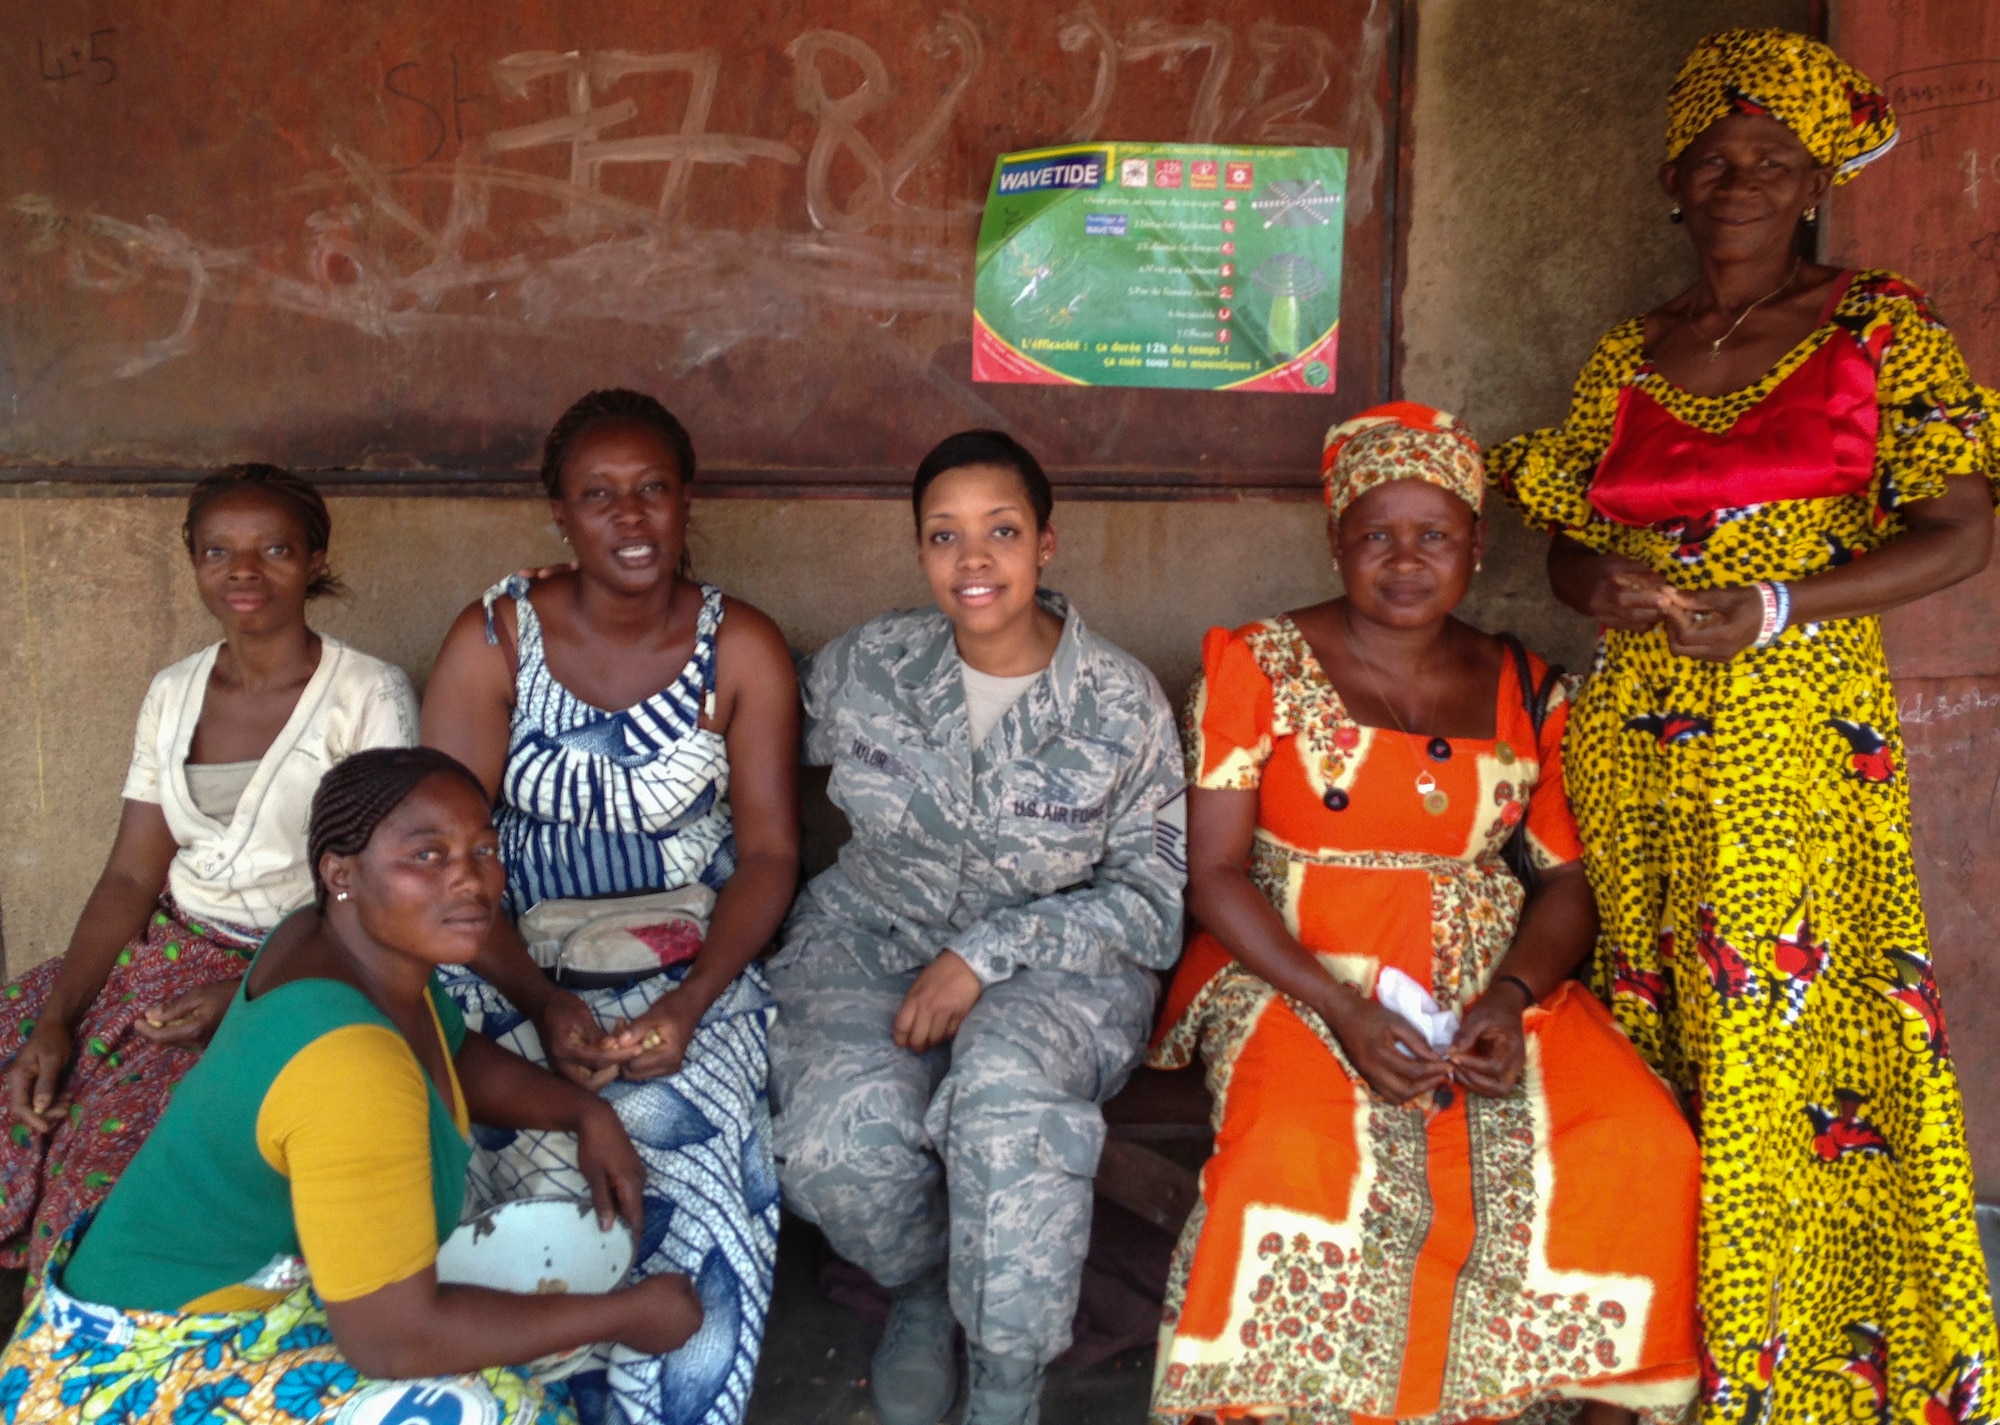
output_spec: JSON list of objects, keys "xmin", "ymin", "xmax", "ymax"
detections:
[{"xmin": 0, "ymin": 0, "xmax": 1402, "ymax": 494}]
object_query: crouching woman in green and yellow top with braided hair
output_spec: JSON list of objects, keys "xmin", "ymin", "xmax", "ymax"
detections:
[{"xmin": 0, "ymin": 749, "xmax": 700, "ymax": 1425}]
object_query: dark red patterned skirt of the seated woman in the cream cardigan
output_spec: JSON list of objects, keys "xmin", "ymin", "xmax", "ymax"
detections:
[{"xmin": 0, "ymin": 895, "xmax": 264, "ymax": 1273}]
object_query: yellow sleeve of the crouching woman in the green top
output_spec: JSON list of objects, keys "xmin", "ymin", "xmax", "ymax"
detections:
[{"xmin": 256, "ymin": 1025, "xmax": 438, "ymax": 1301}]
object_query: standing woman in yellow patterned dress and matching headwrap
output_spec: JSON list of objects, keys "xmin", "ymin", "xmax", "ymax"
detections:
[{"xmin": 1492, "ymin": 30, "xmax": 1996, "ymax": 1425}]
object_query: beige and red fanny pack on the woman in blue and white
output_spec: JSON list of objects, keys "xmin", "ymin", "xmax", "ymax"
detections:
[{"xmin": 520, "ymin": 885, "xmax": 716, "ymax": 989}]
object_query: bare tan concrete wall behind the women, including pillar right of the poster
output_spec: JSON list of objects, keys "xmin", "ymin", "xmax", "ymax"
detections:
[{"xmin": 0, "ymin": 0, "xmax": 1808, "ymax": 975}]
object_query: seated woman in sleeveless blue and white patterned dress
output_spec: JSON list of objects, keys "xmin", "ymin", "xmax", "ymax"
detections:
[{"xmin": 424, "ymin": 390, "xmax": 798, "ymax": 1425}]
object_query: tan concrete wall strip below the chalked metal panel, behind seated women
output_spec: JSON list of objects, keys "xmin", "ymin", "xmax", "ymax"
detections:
[{"xmin": 0, "ymin": 498, "xmax": 1336, "ymax": 975}]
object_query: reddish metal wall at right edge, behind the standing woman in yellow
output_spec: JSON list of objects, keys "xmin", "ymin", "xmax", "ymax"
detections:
[{"xmin": 1828, "ymin": 0, "xmax": 2000, "ymax": 1199}]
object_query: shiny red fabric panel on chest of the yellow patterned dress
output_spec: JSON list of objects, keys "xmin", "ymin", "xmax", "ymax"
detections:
[{"xmin": 1590, "ymin": 332, "xmax": 1880, "ymax": 524}]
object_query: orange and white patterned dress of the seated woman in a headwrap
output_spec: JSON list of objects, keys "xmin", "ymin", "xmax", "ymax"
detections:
[{"xmin": 1152, "ymin": 618, "xmax": 1700, "ymax": 1425}]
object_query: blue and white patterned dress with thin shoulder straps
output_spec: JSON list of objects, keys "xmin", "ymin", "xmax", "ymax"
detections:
[{"xmin": 444, "ymin": 574, "xmax": 778, "ymax": 1425}]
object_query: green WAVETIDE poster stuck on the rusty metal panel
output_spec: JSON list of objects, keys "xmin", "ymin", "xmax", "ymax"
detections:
[{"xmin": 972, "ymin": 144, "xmax": 1348, "ymax": 394}]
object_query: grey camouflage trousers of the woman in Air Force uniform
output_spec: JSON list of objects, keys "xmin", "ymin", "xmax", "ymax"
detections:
[{"xmin": 770, "ymin": 941, "xmax": 1158, "ymax": 1363}]
